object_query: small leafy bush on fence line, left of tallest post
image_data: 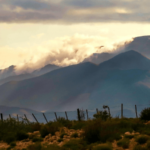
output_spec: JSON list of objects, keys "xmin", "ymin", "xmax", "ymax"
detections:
[{"xmin": 93, "ymin": 110, "xmax": 110, "ymax": 120}]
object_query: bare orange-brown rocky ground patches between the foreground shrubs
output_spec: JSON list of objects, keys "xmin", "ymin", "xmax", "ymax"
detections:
[{"xmin": 0, "ymin": 121, "xmax": 150, "ymax": 150}]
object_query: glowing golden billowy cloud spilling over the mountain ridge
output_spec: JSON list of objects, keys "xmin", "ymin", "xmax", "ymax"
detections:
[{"xmin": 16, "ymin": 34, "xmax": 132, "ymax": 74}]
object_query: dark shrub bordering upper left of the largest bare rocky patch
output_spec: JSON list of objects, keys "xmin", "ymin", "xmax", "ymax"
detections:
[{"xmin": 40, "ymin": 122, "xmax": 60, "ymax": 138}]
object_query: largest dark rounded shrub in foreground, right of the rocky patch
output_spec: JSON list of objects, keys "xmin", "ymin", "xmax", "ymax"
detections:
[{"xmin": 82, "ymin": 119, "xmax": 121, "ymax": 143}]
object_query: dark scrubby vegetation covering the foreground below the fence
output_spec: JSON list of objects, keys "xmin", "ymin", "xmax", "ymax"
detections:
[{"xmin": 0, "ymin": 107, "xmax": 150, "ymax": 150}]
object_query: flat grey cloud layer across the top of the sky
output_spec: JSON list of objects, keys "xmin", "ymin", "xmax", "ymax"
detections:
[{"xmin": 0, "ymin": 0, "xmax": 150, "ymax": 23}]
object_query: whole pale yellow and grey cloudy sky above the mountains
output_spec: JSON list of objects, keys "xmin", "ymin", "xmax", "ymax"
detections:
[{"xmin": 0, "ymin": 0, "xmax": 150, "ymax": 70}]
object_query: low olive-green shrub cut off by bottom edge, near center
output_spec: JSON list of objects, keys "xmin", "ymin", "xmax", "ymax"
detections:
[{"xmin": 62, "ymin": 139, "xmax": 86, "ymax": 150}]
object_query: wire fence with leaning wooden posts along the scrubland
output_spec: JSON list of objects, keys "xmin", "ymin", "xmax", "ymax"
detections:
[{"xmin": 0, "ymin": 104, "xmax": 150, "ymax": 123}]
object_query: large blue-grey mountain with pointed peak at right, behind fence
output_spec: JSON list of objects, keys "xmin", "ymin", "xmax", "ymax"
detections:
[{"xmin": 0, "ymin": 50, "xmax": 150, "ymax": 118}]
